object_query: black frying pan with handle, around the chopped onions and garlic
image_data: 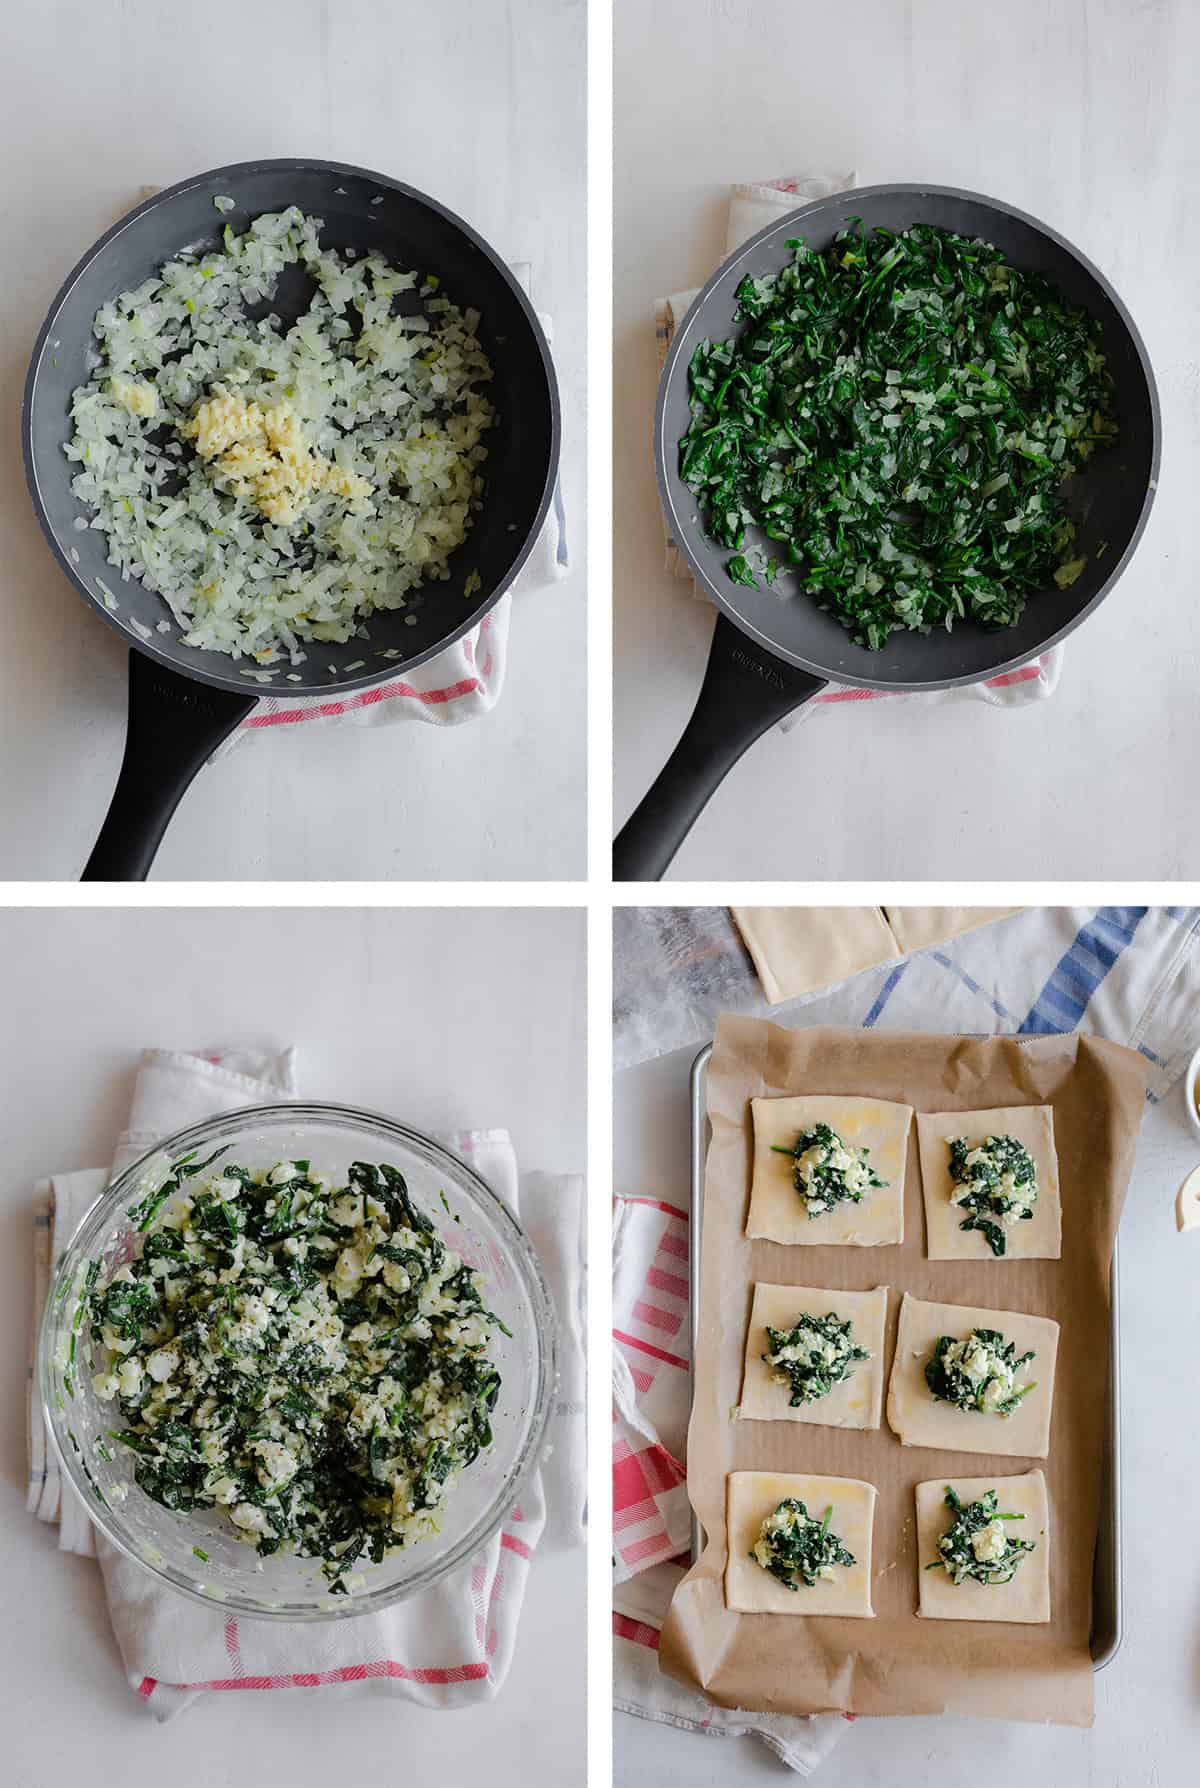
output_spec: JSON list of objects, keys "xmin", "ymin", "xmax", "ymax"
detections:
[{"xmin": 21, "ymin": 161, "xmax": 560, "ymax": 881}]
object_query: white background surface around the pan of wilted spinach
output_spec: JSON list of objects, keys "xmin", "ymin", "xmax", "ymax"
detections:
[{"xmin": 613, "ymin": 0, "xmax": 1200, "ymax": 880}]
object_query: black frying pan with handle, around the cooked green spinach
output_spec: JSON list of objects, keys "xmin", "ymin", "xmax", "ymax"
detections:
[{"xmin": 613, "ymin": 186, "xmax": 1161, "ymax": 881}]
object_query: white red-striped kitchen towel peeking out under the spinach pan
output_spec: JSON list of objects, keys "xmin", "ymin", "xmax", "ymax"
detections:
[{"xmin": 655, "ymin": 170, "xmax": 1062, "ymax": 733}]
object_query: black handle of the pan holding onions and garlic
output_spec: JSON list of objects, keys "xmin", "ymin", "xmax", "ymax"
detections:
[{"xmin": 80, "ymin": 653, "xmax": 256, "ymax": 881}]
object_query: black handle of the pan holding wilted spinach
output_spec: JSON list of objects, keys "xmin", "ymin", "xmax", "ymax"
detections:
[{"xmin": 613, "ymin": 615, "xmax": 824, "ymax": 881}]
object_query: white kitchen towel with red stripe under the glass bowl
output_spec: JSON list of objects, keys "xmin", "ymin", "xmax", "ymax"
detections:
[{"xmin": 29, "ymin": 1050, "xmax": 587, "ymax": 1720}]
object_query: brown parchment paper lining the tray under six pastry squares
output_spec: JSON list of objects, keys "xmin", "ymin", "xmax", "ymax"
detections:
[{"xmin": 658, "ymin": 1017, "xmax": 1146, "ymax": 1725}]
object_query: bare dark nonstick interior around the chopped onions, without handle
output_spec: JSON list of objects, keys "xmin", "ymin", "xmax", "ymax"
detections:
[{"xmin": 23, "ymin": 161, "xmax": 558, "ymax": 696}]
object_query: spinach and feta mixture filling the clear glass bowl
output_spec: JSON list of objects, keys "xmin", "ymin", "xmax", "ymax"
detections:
[{"xmin": 88, "ymin": 1150, "xmax": 508, "ymax": 1593}]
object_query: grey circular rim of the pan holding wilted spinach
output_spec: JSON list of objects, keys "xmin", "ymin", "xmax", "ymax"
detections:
[{"xmin": 653, "ymin": 181, "xmax": 1162, "ymax": 694}]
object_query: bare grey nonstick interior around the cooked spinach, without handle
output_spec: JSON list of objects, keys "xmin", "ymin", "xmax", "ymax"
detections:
[{"xmin": 655, "ymin": 186, "xmax": 1159, "ymax": 690}]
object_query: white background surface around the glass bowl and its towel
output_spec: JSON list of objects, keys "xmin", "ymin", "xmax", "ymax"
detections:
[{"xmin": 0, "ymin": 908, "xmax": 585, "ymax": 1788}]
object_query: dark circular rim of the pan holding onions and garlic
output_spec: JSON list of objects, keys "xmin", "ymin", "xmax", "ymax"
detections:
[{"xmin": 21, "ymin": 156, "xmax": 562, "ymax": 701}]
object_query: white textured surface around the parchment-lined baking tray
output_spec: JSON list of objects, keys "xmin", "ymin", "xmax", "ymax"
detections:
[{"xmin": 613, "ymin": 1050, "xmax": 1200, "ymax": 1788}]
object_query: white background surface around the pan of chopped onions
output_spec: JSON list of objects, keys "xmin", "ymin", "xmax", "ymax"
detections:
[{"xmin": 0, "ymin": 0, "xmax": 587, "ymax": 880}]
